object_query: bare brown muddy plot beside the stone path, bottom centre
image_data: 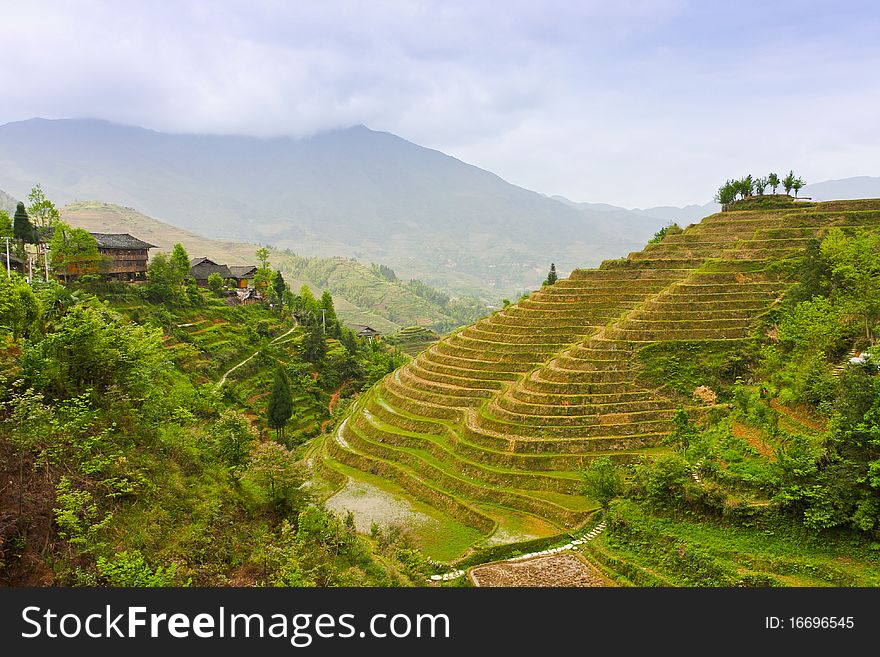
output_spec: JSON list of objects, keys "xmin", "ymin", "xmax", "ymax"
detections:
[{"xmin": 468, "ymin": 552, "xmax": 609, "ymax": 587}]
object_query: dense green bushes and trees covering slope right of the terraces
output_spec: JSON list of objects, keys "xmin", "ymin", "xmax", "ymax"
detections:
[{"xmin": 585, "ymin": 223, "xmax": 880, "ymax": 585}]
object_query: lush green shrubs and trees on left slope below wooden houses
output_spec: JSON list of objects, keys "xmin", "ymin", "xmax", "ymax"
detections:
[{"xmin": 0, "ymin": 241, "xmax": 434, "ymax": 586}]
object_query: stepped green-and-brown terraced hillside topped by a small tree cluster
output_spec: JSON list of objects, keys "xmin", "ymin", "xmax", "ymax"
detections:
[{"xmin": 323, "ymin": 200, "xmax": 880, "ymax": 548}]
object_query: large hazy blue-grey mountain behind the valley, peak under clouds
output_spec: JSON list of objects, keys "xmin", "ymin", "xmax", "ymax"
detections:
[{"xmin": 0, "ymin": 119, "xmax": 663, "ymax": 296}]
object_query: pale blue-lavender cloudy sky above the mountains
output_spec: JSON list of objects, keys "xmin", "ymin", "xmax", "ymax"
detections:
[{"xmin": 0, "ymin": 0, "xmax": 880, "ymax": 207}]
